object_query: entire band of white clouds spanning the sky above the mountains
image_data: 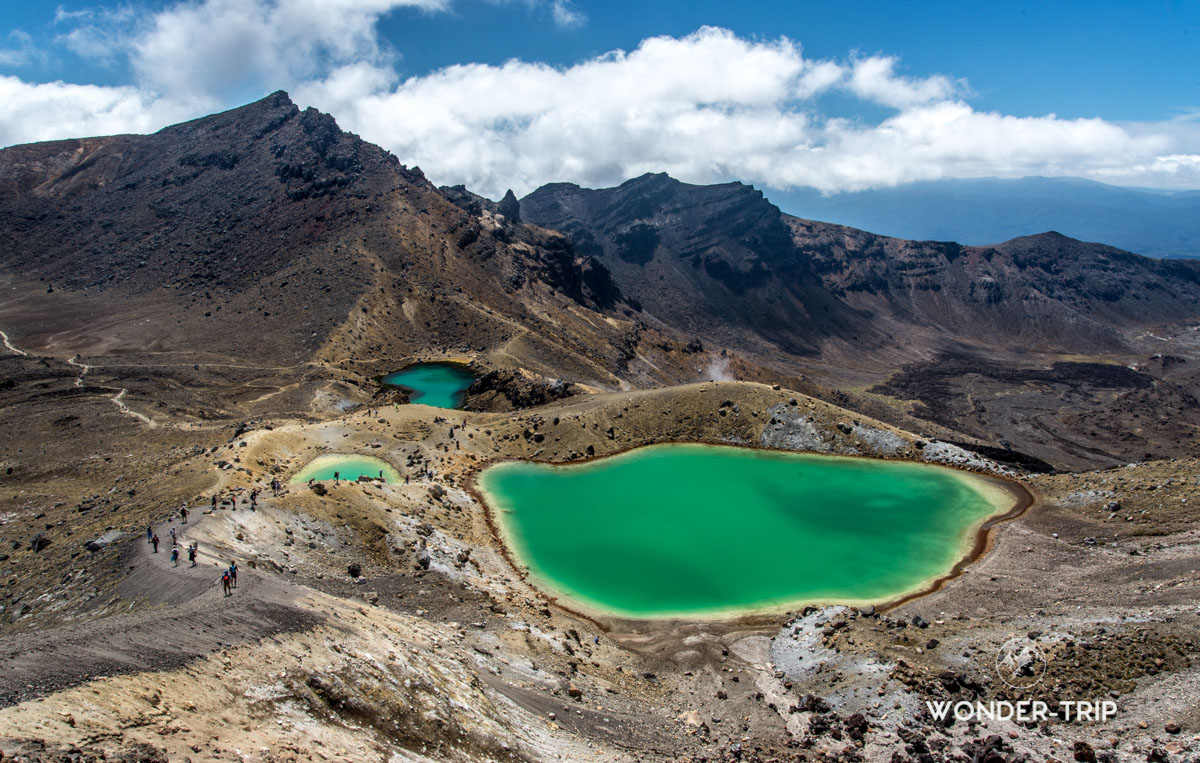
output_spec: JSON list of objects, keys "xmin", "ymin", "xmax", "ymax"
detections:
[{"xmin": 0, "ymin": 10, "xmax": 1200, "ymax": 198}]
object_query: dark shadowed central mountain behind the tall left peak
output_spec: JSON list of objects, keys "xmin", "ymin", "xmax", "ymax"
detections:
[{"xmin": 521, "ymin": 174, "xmax": 877, "ymax": 355}]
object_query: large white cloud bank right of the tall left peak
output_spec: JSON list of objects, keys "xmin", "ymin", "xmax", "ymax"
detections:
[{"xmin": 295, "ymin": 28, "xmax": 1200, "ymax": 198}]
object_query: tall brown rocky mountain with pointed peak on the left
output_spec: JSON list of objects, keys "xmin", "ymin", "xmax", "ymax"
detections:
[{"xmin": 0, "ymin": 92, "xmax": 648, "ymax": 383}]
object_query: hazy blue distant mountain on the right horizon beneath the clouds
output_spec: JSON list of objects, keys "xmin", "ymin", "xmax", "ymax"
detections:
[{"xmin": 767, "ymin": 178, "xmax": 1200, "ymax": 258}]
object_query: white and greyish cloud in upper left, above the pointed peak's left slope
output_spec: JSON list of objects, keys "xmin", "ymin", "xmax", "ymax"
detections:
[{"xmin": 0, "ymin": 0, "xmax": 449, "ymax": 145}]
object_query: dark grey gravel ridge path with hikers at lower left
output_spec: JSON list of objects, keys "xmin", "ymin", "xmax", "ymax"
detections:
[{"xmin": 0, "ymin": 512, "xmax": 324, "ymax": 707}]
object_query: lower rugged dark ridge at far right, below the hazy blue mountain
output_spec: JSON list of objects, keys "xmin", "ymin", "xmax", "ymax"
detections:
[{"xmin": 787, "ymin": 217, "xmax": 1200, "ymax": 352}]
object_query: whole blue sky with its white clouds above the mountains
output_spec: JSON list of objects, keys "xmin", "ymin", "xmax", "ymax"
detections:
[{"xmin": 0, "ymin": 0, "xmax": 1200, "ymax": 196}]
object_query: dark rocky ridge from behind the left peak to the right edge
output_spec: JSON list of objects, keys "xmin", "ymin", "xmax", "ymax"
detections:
[{"xmin": 521, "ymin": 175, "xmax": 1200, "ymax": 358}]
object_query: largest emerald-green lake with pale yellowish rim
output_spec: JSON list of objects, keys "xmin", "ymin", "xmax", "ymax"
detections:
[{"xmin": 479, "ymin": 445, "xmax": 1012, "ymax": 617}]
